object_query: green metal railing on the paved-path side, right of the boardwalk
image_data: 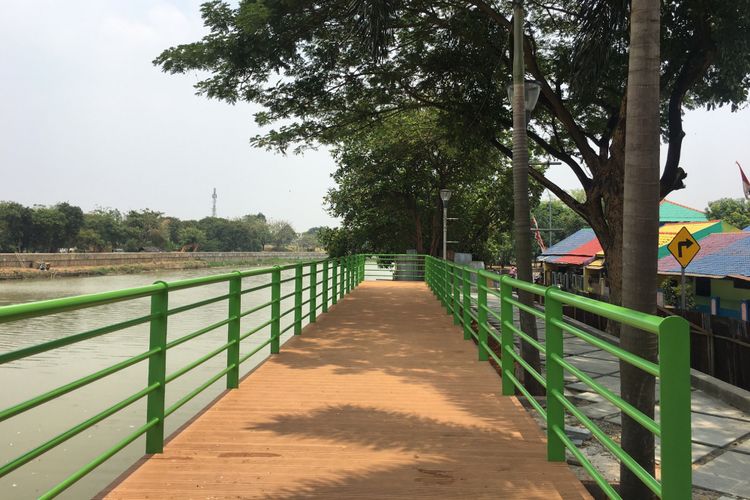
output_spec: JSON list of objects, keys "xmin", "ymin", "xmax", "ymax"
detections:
[{"xmin": 425, "ymin": 257, "xmax": 692, "ymax": 500}]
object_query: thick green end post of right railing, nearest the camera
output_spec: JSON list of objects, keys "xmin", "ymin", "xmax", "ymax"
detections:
[{"xmin": 659, "ymin": 316, "xmax": 693, "ymax": 500}]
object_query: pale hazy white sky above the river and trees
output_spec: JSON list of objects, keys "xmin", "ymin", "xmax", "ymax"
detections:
[{"xmin": 0, "ymin": 0, "xmax": 750, "ymax": 231}]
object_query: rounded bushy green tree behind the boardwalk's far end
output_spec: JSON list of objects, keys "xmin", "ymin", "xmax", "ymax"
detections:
[{"xmin": 326, "ymin": 110, "xmax": 528, "ymax": 261}]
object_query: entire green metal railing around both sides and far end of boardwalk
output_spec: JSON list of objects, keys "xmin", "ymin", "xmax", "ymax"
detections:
[{"xmin": 0, "ymin": 254, "xmax": 691, "ymax": 500}]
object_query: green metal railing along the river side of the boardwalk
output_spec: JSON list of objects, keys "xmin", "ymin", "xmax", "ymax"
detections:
[{"xmin": 0, "ymin": 255, "xmax": 376, "ymax": 498}]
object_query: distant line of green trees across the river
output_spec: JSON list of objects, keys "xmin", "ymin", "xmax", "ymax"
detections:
[{"xmin": 0, "ymin": 201, "xmax": 319, "ymax": 252}]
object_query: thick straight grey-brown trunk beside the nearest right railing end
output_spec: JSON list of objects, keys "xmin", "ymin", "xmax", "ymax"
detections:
[{"xmin": 620, "ymin": 0, "xmax": 660, "ymax": 499}]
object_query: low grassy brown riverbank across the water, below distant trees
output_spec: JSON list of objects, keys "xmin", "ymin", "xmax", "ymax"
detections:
[{"xmin": 0, "ymin": 254, "xmax": 320, "ymax": 281}]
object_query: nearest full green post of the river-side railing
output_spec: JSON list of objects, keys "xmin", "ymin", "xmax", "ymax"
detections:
[{"xmin": 146, "ymin": 281, "xmax": 169, "ymax": 453}]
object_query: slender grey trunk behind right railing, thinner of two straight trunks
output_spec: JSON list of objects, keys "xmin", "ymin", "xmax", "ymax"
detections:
[{"xmin": 516, "ymin": 4, "xmax": 544, "ymax": 396}]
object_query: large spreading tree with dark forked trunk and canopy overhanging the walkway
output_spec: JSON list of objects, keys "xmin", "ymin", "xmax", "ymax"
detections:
[{"xmin": 155, "ymin": 0, "xmax": 750, "ymax": 308}]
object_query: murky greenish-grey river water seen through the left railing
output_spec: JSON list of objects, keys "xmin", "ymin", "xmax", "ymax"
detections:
[{"xmin": 0, "ymin": 268, "xmax": 308, "ymax": 499}]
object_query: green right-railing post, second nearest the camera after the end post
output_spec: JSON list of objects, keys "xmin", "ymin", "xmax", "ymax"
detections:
[{"xmin": 544, "ymin": 287, "xmax": 565, "ymax": 462}]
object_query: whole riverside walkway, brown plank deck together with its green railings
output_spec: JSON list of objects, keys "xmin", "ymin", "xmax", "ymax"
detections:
[{"xmin": 0, "ymin": 255, "xmax": 691, "ymax": 499}]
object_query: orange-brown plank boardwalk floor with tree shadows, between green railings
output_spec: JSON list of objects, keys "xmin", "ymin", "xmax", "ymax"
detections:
[{"xmin": 107, "ymin": 282, "xmax": 590, "ymax": 500}]
